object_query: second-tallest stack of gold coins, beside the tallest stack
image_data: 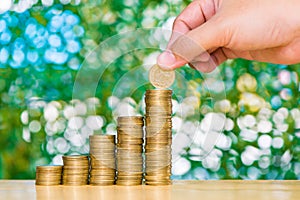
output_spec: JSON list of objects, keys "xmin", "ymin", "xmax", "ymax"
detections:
[{"xmin": 116, "ymin": 116, "xmax": 144, "ymax": 185}]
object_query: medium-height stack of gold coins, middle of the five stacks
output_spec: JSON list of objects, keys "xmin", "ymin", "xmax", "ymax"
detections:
[{"xmin": 90, "ymin": 135, "xmax": 116, "ymax": 185}]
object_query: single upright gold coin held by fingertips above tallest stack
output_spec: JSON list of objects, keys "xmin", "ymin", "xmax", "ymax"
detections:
[{"xmin": 149, "ymin": 65, "xmax": 175, "ymax": 89}]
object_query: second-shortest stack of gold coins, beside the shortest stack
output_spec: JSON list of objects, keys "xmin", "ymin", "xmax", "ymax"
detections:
[{"xmin": 62, "ymin": 155, "xmax": 89, "ymax": 185}]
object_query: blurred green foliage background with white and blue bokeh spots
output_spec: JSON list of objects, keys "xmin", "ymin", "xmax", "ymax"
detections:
[{"xmin": 0, "ymin": 0, "xmax": 300, "ymax": 179}]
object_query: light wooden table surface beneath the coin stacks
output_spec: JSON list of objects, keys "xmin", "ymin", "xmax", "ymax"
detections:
[{"xmin": 0, "ymin": 180, "xmax": 300, "ymax": 200}]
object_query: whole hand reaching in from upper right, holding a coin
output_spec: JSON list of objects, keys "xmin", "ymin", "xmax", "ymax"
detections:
[{"xmin": 157, "ymin": 0, "xmax": 300, "ymax": 72}]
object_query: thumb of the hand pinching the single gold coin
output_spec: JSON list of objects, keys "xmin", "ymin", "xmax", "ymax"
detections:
[{"xmin": 158, "ymin": 20, "xmax": 223, "ymax": 70}]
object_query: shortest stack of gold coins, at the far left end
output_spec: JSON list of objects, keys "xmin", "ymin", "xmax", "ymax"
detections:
[{"xmin": 35, "ymin": 165, "xmax": 62, "ymax": 185}]
